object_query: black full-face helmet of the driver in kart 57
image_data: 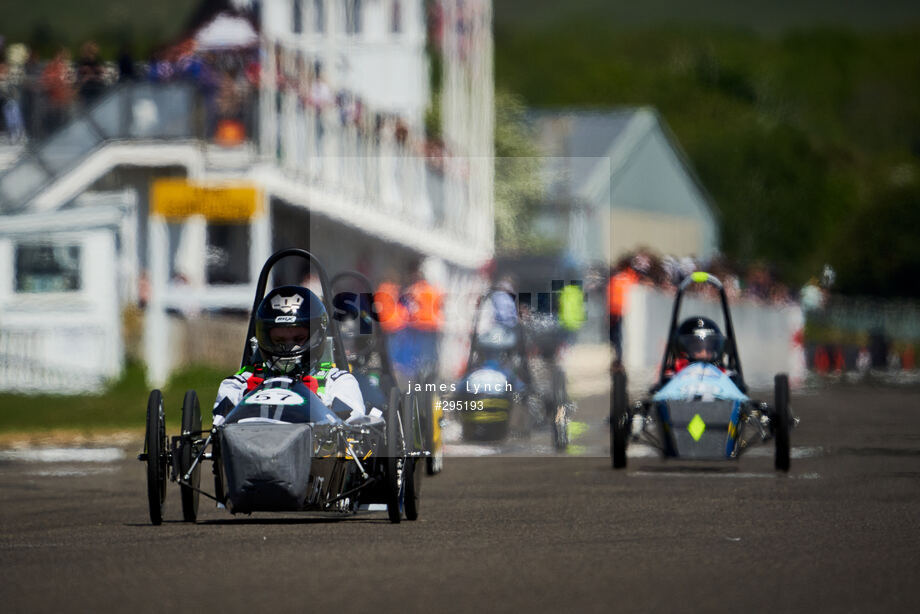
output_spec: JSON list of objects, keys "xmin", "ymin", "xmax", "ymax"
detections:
[{"xmin": 256, "ymin": 286, "xmax": 329, "ymax": 373}]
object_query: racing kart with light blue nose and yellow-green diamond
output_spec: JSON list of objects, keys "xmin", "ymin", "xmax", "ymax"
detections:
[{"xmin": 610, "ymin": 271, "xmax": 797, "ymax": 471}]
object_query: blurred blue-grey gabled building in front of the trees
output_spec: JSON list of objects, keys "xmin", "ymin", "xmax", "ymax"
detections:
[{"xmin": 532, "ymin": 108, "xmax": 718, "ymax": 263}]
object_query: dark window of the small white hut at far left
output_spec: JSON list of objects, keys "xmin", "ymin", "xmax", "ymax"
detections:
[{"xmin": 15, "ymin": 245, "xmax": 80, "ymax": 293}]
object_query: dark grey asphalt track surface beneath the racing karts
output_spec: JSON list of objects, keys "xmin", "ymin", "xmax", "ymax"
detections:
[{"xmin": 0, "ymin": 385, "xmax": 920, "ymax": 613}]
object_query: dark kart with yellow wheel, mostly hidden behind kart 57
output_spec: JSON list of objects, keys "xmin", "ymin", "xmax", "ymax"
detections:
[{"xmin": 332, "ymin": 271, "xmax": 444, "ymax": 481}]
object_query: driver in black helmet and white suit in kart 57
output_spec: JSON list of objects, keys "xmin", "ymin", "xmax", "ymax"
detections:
[{"xmin": 213, "ymin": 286, "xmax": 370, "ymax": 426}]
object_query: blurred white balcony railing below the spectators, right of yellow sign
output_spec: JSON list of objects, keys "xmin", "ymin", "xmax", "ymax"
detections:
[{"xmin": 263, "ymin": 93, "xmax": 492, "ymax": 257}]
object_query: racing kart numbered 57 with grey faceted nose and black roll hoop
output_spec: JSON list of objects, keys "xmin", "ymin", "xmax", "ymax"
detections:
[{"xmin": 138, "ymin": 249, "xmax": 425, "ymax": 525}]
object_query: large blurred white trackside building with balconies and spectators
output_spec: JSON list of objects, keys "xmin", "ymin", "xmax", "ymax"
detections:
[{"xmin": 0, "ymin": 0, "xmax": 494, "ymax": 389}]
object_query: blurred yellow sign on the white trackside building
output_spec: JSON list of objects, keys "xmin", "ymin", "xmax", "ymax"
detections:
[{"xmin": 150, "ymin": 179, "xmax": 261, "ymax": 222}]
